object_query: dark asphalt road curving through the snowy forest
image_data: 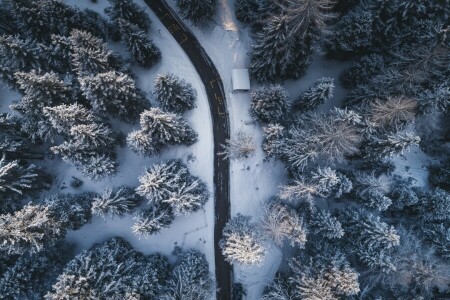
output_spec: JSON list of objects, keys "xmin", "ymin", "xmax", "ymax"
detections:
[{"xmin": 144, "ymin": 0, "xmax": 232, "ymax": 300}]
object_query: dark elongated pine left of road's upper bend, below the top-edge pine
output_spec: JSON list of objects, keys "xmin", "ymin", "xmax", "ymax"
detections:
[{"xmin": 119, "ymin": 19, "xmax": 161, "ymax": 68}]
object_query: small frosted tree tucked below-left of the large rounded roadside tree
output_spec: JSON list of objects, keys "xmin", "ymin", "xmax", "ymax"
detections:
[{"xmin": 131, "ymin": 204, "xmax": 175, "ymax": 237}]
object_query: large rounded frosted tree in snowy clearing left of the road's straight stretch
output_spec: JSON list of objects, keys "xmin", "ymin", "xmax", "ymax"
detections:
[{"xmin": 136, "ymin": 160, "xmax": 209, "ymax": 215}]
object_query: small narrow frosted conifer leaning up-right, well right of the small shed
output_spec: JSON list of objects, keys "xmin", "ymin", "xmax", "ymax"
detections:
[{"xmin": 293, "ymin": 77, "xmax": 334, "ymax": 112}]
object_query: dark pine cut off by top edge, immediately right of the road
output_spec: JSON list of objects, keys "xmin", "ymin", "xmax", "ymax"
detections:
[{"xmin": 177, "ymin": 0, "xmax": 217, "ymax": 25}]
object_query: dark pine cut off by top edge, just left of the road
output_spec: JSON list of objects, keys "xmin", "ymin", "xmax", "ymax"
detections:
[{"xmin": 105, "ymin": 0, "xmax": 151, "ymax": 32}]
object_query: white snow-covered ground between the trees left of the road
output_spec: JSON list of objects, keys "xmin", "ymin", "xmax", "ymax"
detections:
[{"xmin": 57, "ymin": 0, "xmax": 214, "ymax": 273}]
